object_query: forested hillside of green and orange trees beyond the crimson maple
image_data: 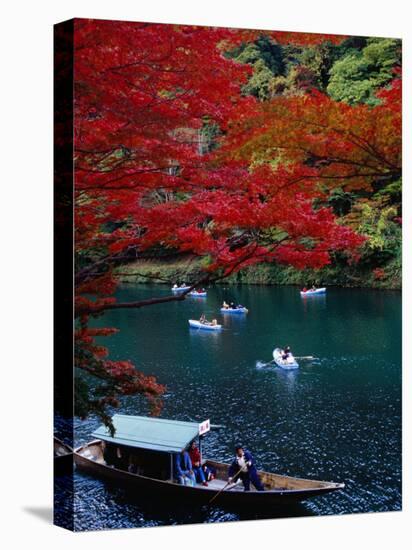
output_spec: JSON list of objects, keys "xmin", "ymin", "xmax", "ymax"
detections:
[{"xmin": 122, "ymin": 31, "xmax": 402, "ymax": 288}]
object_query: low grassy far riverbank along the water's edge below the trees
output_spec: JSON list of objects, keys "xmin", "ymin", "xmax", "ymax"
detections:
[{"xmin": 119, "ymin": 258, "xmax": 402, "ymax": 290}]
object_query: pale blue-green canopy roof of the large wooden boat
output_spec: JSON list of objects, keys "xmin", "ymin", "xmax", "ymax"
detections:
[{"xmin": 92, "ymin": 414, "xmax": 202, "ymax": 453}]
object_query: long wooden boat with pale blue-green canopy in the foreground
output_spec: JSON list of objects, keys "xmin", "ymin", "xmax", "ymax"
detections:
[{"xmin": 74, "ymin": 415, "xmax": 344, "ymax": 508}]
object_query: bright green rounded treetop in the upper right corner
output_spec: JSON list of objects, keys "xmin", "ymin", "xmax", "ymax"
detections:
[{"xmin": 327, "ymin": 38, "xmax": 400, "ymax": 105}]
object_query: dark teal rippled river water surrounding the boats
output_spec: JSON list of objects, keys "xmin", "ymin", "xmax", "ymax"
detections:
[{"xmin": 58, "ymin": 285, "xmax": 401, "ymax": 530}]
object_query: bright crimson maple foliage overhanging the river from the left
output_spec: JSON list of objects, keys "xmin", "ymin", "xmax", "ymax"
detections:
[{"xmin": 74, "ymin": 20, "xmax": 362, "ymax": 423}]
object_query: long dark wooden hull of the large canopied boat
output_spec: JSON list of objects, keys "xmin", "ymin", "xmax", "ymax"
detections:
[{"xmin": 74, "ymin": 442, "xmax": 344, "ymax": 508}]
